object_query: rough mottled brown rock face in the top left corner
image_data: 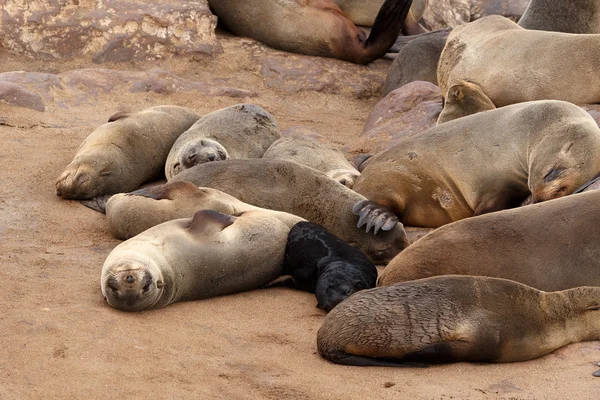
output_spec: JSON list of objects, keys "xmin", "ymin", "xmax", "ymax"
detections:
[{"xmin": 0, "ymin": 0, "xmax": 222, "ymax": 62}]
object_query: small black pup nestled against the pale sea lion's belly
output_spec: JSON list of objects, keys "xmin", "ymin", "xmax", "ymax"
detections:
[{"xmin": 283, "ymin": 222, "xmax": 377, "ymax": 311}]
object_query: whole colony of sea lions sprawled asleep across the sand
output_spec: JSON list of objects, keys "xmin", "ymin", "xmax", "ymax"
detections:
[{"xmin": 56, "ymin": 0, "xmax": 600, "ymax": 376}]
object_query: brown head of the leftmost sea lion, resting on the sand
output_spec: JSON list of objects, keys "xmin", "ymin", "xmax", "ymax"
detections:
[{"xmin": 56, "ymin": 160, "xmax": 115, "ymax": 199}]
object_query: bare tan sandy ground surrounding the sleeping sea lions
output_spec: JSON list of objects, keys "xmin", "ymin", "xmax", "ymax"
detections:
[{"xmin": 0, "ymin": 32, "xmax": 600, "ymax": 399}]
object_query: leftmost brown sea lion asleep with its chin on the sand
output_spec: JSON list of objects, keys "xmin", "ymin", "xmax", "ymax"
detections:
[{"xmin": 56, "ymin": 106, "xmax": 200, "ymax": 199}]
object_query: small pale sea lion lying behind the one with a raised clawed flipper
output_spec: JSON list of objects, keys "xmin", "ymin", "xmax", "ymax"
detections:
[{"xmin": 262, "ymin": 136, "xmax": 360, "ymax": 188}]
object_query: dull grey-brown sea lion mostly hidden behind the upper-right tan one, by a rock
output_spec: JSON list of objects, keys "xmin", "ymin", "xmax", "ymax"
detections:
[{"xmin": 383, "ymin": 28, "xmax": 451, "ymax": 96}]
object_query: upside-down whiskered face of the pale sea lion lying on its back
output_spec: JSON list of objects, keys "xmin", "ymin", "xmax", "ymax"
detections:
[{"xmin": 101, "ymin": 252, "xmax": 165, "ymax": 311}]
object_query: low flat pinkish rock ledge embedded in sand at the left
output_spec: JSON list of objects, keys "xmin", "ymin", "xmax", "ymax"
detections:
[{"xmin": 0, "ymin": 68, "xmax": 256, "ymax": 108}]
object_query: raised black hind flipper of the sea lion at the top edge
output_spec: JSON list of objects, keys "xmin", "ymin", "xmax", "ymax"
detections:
[{"xmin": 359, "ymin": 0, "xmax": 412, "ymax": 64}]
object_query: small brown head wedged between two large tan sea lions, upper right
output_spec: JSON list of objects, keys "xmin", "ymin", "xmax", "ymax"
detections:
[{"xmin": 437, "ymin": 81, "xmax": 496, "ymax": 125}]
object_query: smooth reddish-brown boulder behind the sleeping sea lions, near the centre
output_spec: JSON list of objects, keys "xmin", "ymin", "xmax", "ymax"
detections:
[{"xmin": 347, "ymin": 81, "xmax": 442, "ymax": 154}]
